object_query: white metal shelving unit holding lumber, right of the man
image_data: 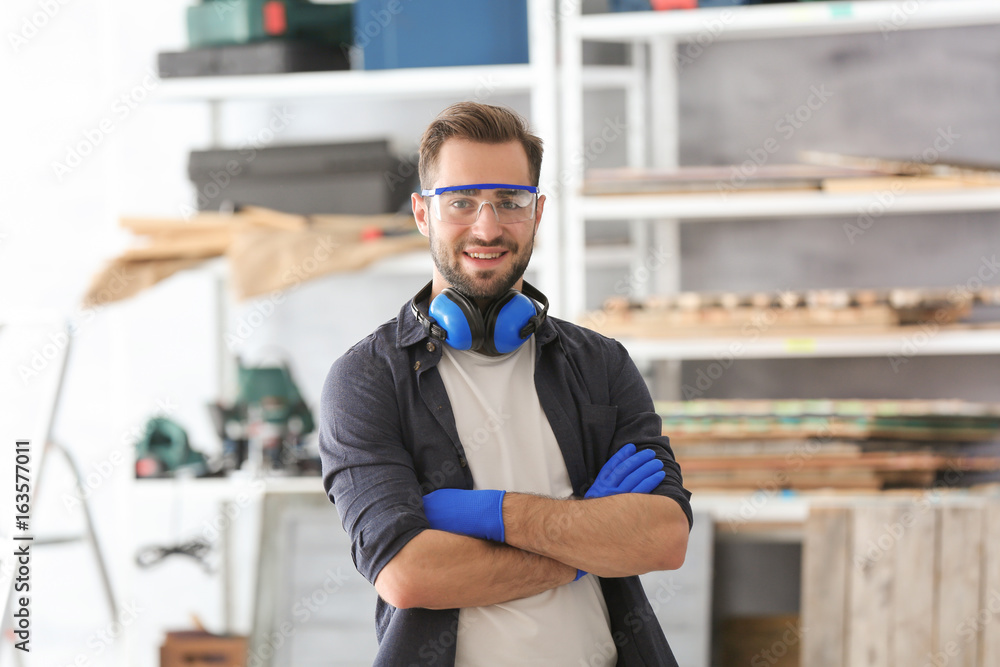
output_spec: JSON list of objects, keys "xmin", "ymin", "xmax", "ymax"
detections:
[{"xmin": 560, "ymin": 9, "xmax": 1000, "ymax": 665}]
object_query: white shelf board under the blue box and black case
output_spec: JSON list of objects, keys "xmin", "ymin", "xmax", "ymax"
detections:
[{"xmin": 157, "ymin": 65, "xmax": 637, "ymax": 102}]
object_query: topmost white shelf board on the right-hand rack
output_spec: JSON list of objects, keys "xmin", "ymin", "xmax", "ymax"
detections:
[{"xmin": 567, "ymin": 0, "xmax": 1000, "ymax": 42}]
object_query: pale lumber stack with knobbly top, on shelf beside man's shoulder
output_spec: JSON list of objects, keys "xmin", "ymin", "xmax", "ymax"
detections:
[{"xmin": 587, "ymin": 287, "xmax": 1000, "ymax": 338}]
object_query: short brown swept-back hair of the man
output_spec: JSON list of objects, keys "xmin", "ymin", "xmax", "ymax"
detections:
[{"xmin": 420, "ymin": 102, "xmax": 542, "ymax": 189}]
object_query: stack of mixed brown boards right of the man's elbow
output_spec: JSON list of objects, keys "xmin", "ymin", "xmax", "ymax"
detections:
[{"xmin": 656, "ymin": 400, "xmax": 1000, "ymax": 489}]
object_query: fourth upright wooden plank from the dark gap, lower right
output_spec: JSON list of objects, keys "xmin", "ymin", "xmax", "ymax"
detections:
[{"xmin": 934, "ymin": 504, "xmax": 983, "ymax": 667}]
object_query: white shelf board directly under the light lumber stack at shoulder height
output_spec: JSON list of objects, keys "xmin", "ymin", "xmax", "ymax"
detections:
[{"xmin": 620, "ymin": 325, "xmax": 1000, "ymax": 364}]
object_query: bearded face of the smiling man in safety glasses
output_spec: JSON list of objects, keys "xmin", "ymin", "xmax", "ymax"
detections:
[{"xmin": 412, "ymin": 138, "xmax": 544, "ymax": 302}]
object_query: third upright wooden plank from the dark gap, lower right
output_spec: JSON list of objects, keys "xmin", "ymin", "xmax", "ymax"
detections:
[{"xmin": 890, "ymin": 500, "xmax": 938, "ymax": 667}]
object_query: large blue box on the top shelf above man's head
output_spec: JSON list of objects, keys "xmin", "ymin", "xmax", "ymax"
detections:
[{"xmin": 354, "ymin": 0, "xmax": 528, "ymax": 69}]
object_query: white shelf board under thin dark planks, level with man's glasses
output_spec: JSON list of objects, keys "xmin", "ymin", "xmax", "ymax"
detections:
[{"xmin": 579, "ymin": 188, "xmax": 1000, "ymax": 220}]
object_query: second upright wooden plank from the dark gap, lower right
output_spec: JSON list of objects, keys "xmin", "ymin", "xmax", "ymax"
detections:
[{"xmin": 847, "ymin": 505, "xmax": 896, "ymax": 667}]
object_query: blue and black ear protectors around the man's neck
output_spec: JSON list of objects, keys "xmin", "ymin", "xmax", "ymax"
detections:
[{"xmin": 410, "ymin": 281, "xmax": 549, "ymax": 354}]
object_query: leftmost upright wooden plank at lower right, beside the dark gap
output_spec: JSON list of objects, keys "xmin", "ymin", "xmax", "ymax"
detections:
[{"xmin": 802, "ymin": 507, "xmax": 851, "ymax": 667}]
